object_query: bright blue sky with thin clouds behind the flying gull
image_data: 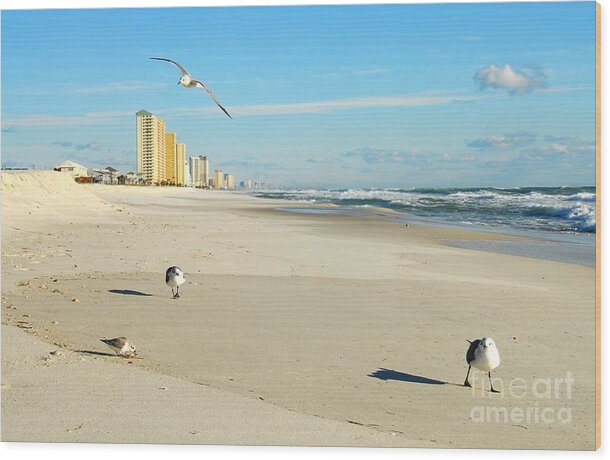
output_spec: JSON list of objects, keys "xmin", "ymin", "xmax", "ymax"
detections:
[{"xmin": 2, "ymin": 2, "xmax": 595, "ymax": 188}]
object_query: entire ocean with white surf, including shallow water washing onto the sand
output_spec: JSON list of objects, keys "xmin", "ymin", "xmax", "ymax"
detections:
[{"xmin": 248, "ymin": 187, "xmax": 596, "ymax": 266}]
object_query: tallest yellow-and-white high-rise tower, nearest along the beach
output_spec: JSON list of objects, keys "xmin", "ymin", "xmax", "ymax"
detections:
[{"xmin": 136, "ymin": 110, "xmax": 166, "ymax": 184}]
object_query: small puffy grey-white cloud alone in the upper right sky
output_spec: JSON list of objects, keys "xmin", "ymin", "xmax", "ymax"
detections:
[{"xmin": 473, "ymin": 64, "xmax": 547, "ymax": 95}]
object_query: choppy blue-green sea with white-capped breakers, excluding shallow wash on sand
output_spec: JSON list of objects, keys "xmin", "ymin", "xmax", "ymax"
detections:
[{"xmin": 257, "ymin": 187, "xmax": 596, "ymax": 233}]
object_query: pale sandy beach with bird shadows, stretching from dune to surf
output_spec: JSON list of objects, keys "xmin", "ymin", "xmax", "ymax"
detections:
[{"xmin": 2, "ymin": 172, "xmax": 595, "ymax": 449}]
